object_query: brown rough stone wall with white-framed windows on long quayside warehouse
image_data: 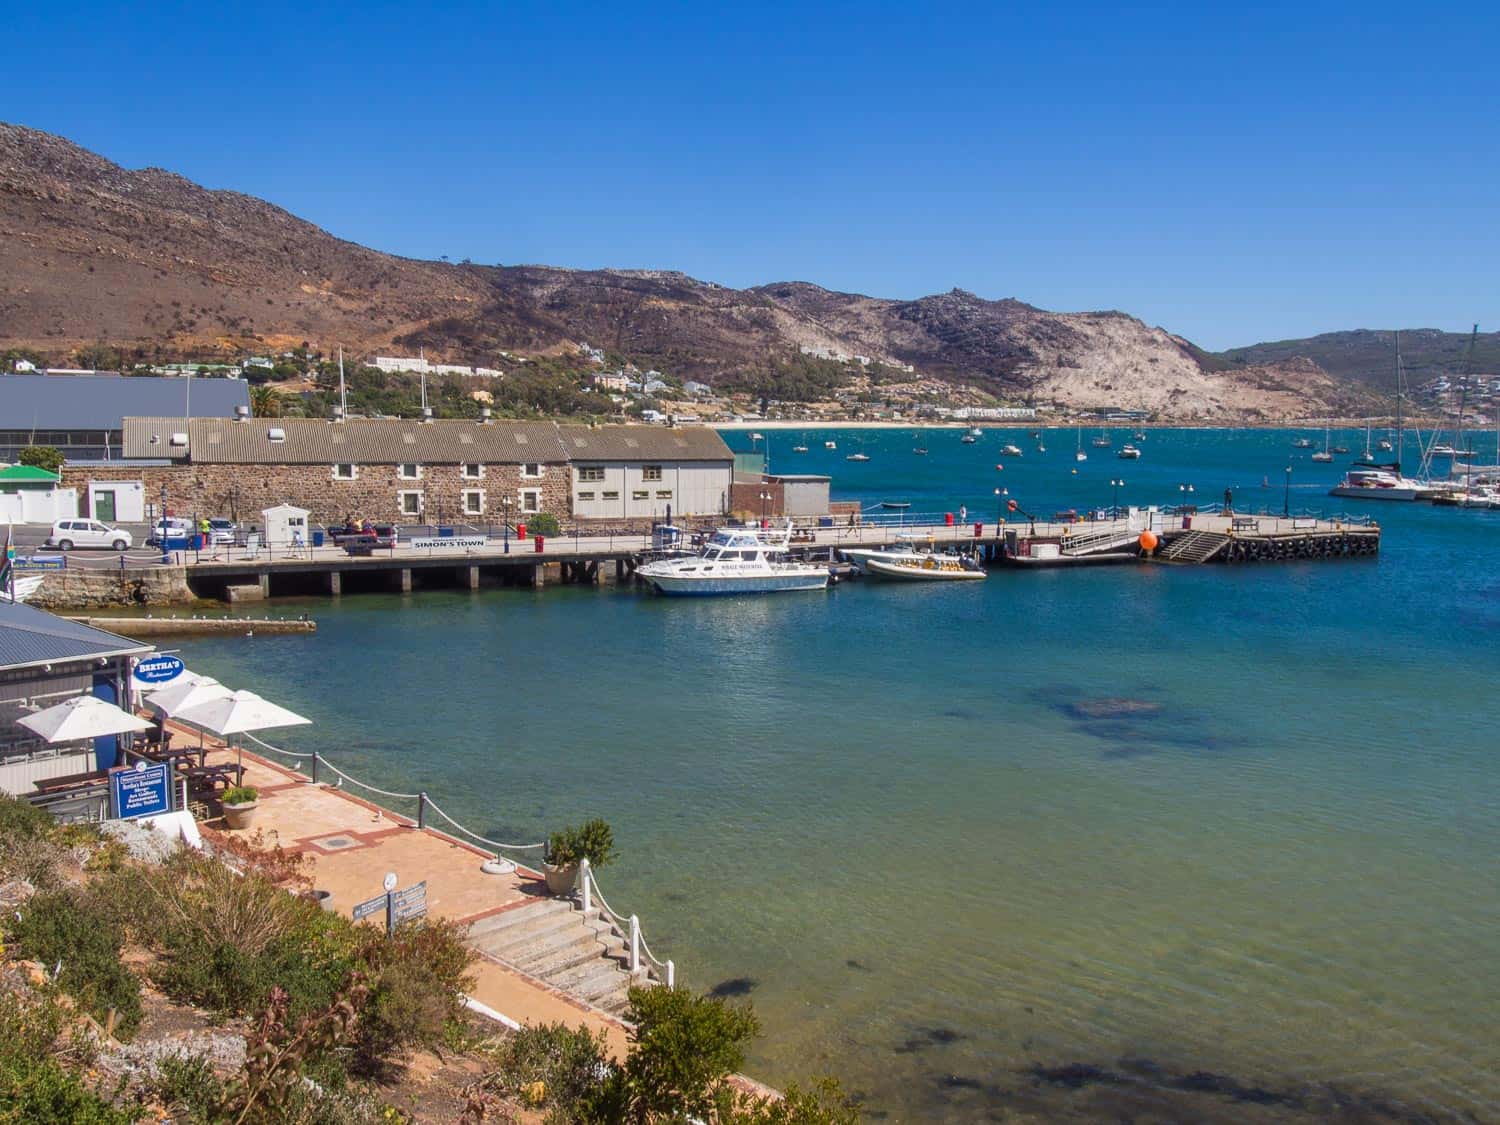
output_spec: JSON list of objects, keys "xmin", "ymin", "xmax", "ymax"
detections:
[{"xmin": 63, "ymin": 464, "xmax": 572, "ymax": 525}]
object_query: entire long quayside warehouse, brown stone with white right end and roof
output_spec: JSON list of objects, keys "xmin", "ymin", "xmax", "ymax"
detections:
[{"xmin": 65, "ymin": 419, "xmax": 734, "ymax": 525}]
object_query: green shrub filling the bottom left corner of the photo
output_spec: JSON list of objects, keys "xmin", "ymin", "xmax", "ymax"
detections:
[{"xmin": 0, "ymin": 993, "xmax": 135, "ymax": 1125}]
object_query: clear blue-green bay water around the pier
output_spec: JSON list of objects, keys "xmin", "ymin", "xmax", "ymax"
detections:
[{"xmin": 170, "ymin": 429, "xmax": 1500, "ymax": 1121}]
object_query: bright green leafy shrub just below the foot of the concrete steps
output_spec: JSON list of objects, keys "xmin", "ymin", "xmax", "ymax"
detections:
[{"xmin": 582, "ymin": 987, "xmax": 761, "ymax": 1125}]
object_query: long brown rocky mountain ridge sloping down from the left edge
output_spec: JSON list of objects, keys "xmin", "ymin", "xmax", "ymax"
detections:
[{"xmin": 0, "ymin": 125, "xmax": 1364, "ymax": 419}]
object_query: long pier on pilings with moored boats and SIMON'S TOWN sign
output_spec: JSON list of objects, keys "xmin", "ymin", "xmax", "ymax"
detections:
[{"xmin": 158, "ymin": 509, "xmax": 1380, "ymax": 603}]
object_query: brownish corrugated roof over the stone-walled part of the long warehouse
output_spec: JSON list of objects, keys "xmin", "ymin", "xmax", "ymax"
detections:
[{"xmin": 125, "ymin": 419, "xmax": 567, "ymax": 465}]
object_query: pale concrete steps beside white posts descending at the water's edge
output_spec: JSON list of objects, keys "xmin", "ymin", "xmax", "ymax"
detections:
[{"xmin": 468, "ymin": 899, "xmax": 648, "ymax": 1016}]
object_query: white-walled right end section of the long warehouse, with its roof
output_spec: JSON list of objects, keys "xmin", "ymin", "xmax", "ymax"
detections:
[{"xmin": 558, "ymin": 426, "xmax": 735, "ymax": 519}]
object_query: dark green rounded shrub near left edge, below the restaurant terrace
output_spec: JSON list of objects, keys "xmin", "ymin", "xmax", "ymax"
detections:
[{"xmin": 11, "ymin": 890, "xmax": 141, "ymax": 1037}]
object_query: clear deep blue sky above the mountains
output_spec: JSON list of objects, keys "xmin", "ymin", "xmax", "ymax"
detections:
[{"xmin": 0, "ymin": 3, "xmax": 1500, "ymax": 348}]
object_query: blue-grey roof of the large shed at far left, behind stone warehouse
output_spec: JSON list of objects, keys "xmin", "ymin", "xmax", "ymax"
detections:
[{"xmin": 0, "ymin": 375, "xmax": 251, "ymax": 431}]
